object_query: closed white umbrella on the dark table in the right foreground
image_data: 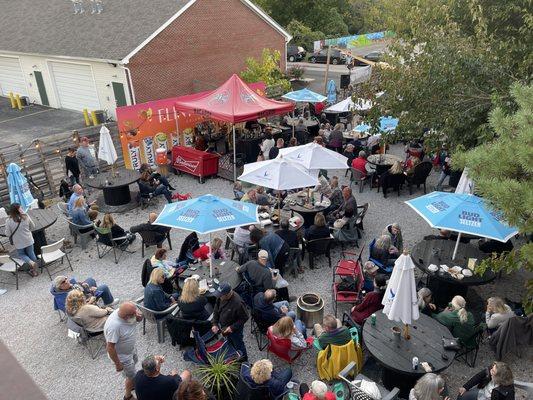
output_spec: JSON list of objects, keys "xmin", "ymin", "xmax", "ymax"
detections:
[{"xmin": 381, "ymin": 251, "xmax": 420, "ymax": 339}]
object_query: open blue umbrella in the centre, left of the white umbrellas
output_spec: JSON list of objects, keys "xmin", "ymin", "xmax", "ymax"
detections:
[{"xmin": 154, "ymin": 194, "xmax": 259, "ymax": 276}]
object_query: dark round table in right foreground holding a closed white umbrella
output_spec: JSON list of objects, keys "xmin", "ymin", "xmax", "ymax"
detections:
[{"xmin": 362, "ymin": 310, "xmax": 455, "ymax": 398}]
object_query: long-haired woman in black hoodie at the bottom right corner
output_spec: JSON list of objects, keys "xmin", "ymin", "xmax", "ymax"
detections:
[{"xmin": 457, "ymin": 361, "xmax": 515, "ymax": 400}]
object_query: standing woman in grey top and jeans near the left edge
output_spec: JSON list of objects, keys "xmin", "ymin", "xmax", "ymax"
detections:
[{"xmin": 5, "ymin": 203, "xmax": 38, "ymax": 277}]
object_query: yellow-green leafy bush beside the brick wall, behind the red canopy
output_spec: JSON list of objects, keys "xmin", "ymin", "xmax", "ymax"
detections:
[{"xmin": 241, "ymin": 49, "xmax": 291, "ymax": 97}]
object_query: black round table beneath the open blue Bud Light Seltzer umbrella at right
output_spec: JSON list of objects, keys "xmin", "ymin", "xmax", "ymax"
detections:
[{"xmin": 411, "ymin": 239, "xmax": 496, "ymax": 308}]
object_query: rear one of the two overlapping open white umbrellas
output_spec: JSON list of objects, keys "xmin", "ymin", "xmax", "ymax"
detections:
[{"xmin": 279, "ymin": 143, "xmax": 348, "ymax": 170}]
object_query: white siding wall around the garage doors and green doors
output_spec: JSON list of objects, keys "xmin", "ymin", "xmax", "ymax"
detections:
[{"xmin": 0, "ymin": 52, "xmax": 131, "ymax": 118}]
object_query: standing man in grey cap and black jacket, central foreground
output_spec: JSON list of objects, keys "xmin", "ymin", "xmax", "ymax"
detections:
[{"xmin": 211, "ymin": 282, "xmax": 249, "ymax": 362}]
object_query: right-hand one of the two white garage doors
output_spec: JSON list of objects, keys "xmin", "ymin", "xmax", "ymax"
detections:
[{"xmin": 51, "ymin": 62, "xmax": 100, "ymax": 111}]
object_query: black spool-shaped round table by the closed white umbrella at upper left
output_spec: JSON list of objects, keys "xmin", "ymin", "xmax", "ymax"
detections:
[{"xmin": 85, "ymin": 169, "xmax": 139, "ymax": 212}]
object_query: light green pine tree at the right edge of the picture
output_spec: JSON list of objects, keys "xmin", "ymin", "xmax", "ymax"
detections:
[{"xmin": 453, "ymin": 84, "xmax": 533, "ymax": 312}]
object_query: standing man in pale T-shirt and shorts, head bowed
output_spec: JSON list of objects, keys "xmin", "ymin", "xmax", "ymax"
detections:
[{"xmin": 104, "ymin": 301, "xmax": 143, "ymax": 400}]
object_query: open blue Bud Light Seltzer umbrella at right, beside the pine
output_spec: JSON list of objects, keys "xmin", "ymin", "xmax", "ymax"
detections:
[{"xmin": 406, "ymin": 192, "xmax": 518, "ymax": 259}]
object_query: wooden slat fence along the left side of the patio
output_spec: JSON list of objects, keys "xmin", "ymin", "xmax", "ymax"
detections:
[{"xmin": 0, "ymin": 123, "xmax": 124, "ymax": 207}]
